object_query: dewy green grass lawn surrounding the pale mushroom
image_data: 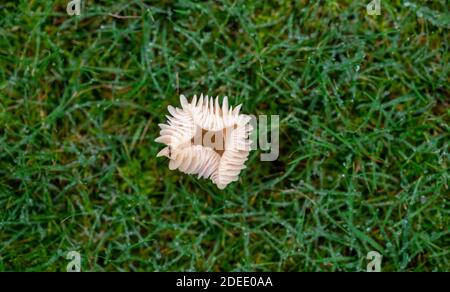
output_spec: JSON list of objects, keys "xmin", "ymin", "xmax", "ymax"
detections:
[{"xmin": 0, "ymin": 0, "xmax": 450, "ymax": 271}]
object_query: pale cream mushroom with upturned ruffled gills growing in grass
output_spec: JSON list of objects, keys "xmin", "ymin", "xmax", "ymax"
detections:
[{"xmin": 155, "ymin": 94, "xmax": 253, "ymax": 189}]
